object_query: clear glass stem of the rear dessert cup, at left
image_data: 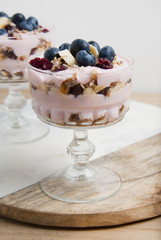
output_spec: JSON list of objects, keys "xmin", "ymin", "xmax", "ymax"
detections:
[{"xmin": 4, "ymin": 83, "xmax": 28, "ymax": 128}]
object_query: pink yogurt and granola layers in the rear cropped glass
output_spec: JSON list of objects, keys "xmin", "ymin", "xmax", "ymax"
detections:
[{"xmin": 0, "ymin": 28, "xmax": 54, "ymax": 78}]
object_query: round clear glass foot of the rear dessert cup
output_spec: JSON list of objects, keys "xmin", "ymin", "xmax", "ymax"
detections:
[{"xmin": 0, "ymin": 118, "xmax": 49, "ymax": 144}]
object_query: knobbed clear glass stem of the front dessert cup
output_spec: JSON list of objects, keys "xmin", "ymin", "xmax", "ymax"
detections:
[{"xmin": 65, "ymin": 129, "xmax": 95, "ymax": 180}]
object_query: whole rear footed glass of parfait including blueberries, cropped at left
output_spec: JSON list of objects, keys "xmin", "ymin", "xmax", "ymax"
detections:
[{"xmin": 0, "ymin": 12, "xmax": 54, "ymax": 143}]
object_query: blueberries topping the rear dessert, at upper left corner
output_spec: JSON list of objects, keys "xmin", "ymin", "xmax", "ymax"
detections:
[{"xmin": 0, "ymin": 12, "xmax": 39, "ymax": 35}]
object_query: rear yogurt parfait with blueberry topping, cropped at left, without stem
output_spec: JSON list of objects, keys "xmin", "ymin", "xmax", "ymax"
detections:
[{"xmin": 0, "ymin": 12, "xmax": 54, "ymax": 80}]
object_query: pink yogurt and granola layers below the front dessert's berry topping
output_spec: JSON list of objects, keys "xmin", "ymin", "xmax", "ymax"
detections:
[{"xmin": 29, "ymin": 56, "xmax": 133, "ymax": 126}]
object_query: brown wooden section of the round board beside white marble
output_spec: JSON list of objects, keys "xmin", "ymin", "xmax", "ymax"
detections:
[{"xmin": 0, "ymin": 134, "xmax": 161, "ymax": 227}]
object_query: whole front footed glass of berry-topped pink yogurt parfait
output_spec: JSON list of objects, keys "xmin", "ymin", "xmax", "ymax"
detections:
[{"xmin": 29, "ymin": 39, "xmax": 133, "ymax": 203}]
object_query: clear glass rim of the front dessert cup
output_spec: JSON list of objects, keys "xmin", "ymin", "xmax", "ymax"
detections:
[{"xmin": 28, "ymin": 53, "xmax": 134, "ymax": 77}]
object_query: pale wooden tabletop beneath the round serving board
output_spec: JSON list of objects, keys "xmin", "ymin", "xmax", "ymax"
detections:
[{"xmin": 0, "ymin": 89, "xmax": 161, "ymax": 240}]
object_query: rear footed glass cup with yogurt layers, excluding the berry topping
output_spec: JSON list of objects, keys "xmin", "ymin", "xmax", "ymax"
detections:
[{"xmin": 0, "ymin": 25, "xmax": 54, "ymax": 143}]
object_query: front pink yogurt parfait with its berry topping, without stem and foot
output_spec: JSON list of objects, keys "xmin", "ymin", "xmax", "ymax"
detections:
[{"xmin": 29, "ymin": 39, "xmax": 133, "ymax": 127}]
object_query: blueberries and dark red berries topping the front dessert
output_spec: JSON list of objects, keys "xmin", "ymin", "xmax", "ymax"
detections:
[{"xmin": 31, "ymin": 39, "xmax": 115, "ymax": 71}]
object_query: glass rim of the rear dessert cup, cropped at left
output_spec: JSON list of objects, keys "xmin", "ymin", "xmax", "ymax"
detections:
[{"xmin": 0, "ymin": 21, "xmax": 55, "ymax": 40}]
